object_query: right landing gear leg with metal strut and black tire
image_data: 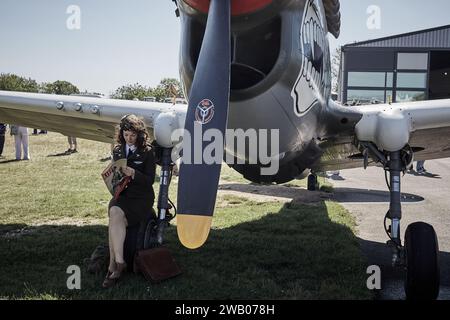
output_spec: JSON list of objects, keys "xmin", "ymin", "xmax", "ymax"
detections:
[{"xmin": 363, "ymin": 143, "xmax": 440, "ymax": 300}]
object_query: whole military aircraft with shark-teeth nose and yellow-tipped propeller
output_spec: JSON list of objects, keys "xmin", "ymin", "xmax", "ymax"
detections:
[{"xmin": 0, "ymin": 0, "xmax": 450, "ymax": 299}]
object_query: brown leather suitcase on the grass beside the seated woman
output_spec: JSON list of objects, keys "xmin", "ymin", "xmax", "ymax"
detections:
[{"xmin": 133, "ymin": 247, "xmax": 181, "ymax": 283}]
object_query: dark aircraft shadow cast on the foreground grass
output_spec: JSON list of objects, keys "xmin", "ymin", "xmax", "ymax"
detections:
[{"xmin": 0, "ymin": 202, "xmax": 373, "ymax": 299}]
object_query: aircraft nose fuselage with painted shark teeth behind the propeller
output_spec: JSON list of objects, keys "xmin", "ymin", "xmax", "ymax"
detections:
[{"xmin": 179, "ymin": 0, "xmax": 342, "ymax": 183}]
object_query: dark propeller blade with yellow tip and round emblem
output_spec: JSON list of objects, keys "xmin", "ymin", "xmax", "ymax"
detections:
[{"xmin": 177, "ymin": 0, "xmax": 231, "ymax": 249}]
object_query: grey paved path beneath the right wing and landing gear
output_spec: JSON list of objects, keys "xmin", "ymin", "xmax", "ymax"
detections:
[{"xmin": 330, "ymin": 159, "xmax": 450, "ymax": 300}]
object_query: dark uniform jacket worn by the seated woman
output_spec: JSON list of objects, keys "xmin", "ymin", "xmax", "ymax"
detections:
[{"xmin": 113, "ymin": 145, "xmax": 156, "ymax": 203}]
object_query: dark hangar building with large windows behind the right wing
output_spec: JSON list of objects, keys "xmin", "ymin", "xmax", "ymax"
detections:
[{"xmin": 338, "ymin": 25, "xmax": 450, "ymax": 104}]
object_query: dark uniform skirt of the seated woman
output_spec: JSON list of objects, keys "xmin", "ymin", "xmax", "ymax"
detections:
[{"xmin": 108, "ymin": 195, "xmax": 156, "ymax": 226}]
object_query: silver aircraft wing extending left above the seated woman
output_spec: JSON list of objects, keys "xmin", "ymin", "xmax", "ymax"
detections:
[{"xmin": 0, "ymin": 91, "xmax": 187, "ymax": 143}]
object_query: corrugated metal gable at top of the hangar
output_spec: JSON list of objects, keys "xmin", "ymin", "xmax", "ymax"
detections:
[{"xmin": 347, "ymin": 26, "xmax": 450, "ymax": 48}]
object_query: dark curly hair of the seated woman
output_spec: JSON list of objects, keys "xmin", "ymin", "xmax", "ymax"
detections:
[{"xmin": 115, "ymin": 114, "xmax": 149, "ymax": 150}]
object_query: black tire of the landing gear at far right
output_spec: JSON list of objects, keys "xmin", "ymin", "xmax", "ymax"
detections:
[{"xmin": 405, "ymin": 222, "xmax": 440, "ymax": 300}]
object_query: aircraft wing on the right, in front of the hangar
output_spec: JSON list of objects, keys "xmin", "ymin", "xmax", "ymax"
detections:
[{"xmin": 314, "ymin": 99, "xmax": 450, "ymax": 171}]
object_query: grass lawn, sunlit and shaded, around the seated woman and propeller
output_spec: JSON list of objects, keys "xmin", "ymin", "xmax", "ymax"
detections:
[{"xmin": 0, "ymin": 133, "xmax": 372, "ymax": 299}]
